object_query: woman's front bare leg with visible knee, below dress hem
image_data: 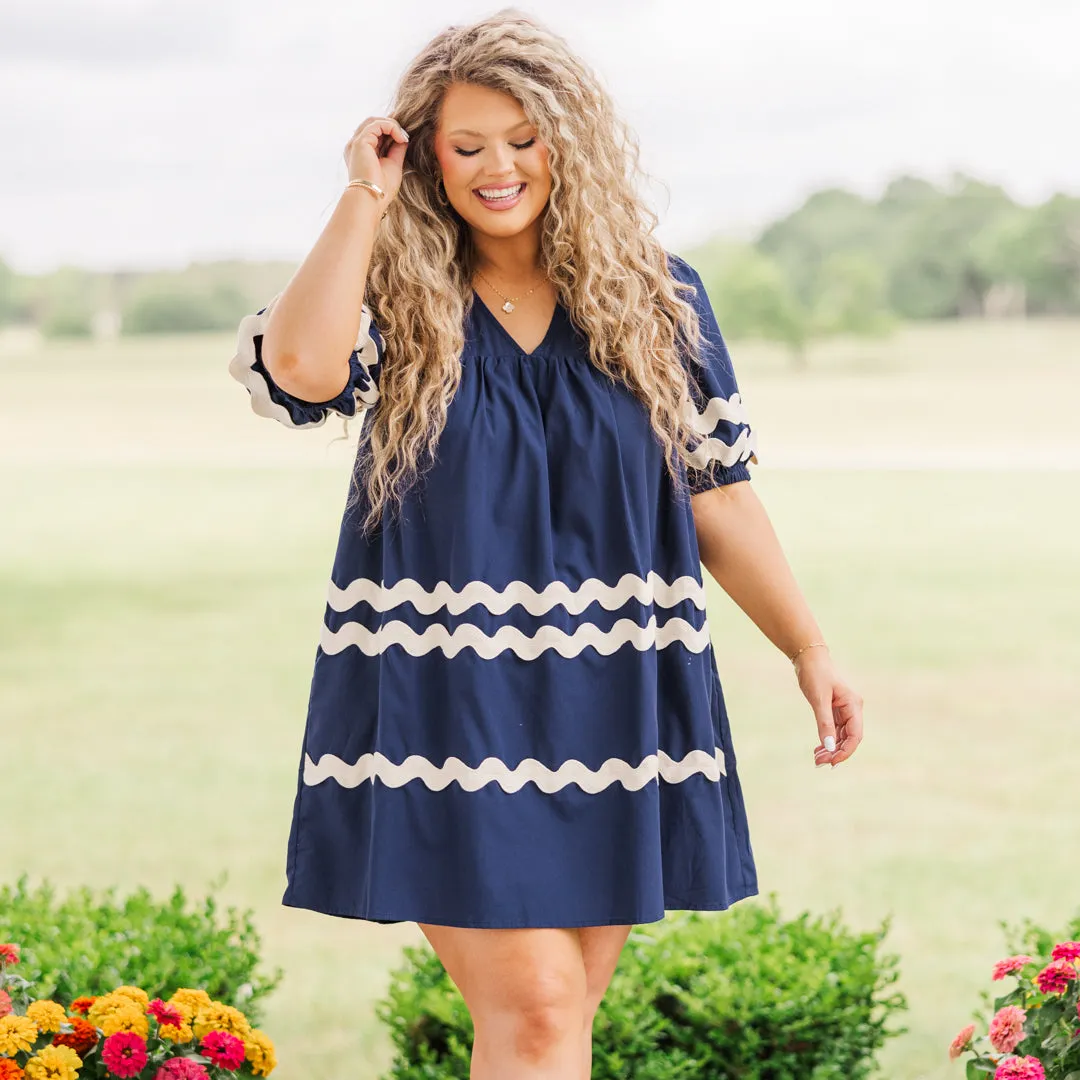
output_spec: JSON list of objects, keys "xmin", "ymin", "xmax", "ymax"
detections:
[{"xmin": 420, "ymin": 923, "xmax": 588, "ymax": 1080}]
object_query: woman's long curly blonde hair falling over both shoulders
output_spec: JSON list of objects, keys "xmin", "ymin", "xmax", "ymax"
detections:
[{"xmin": 349, "ymin": 8, "xmax": 701, "ymax": 530}]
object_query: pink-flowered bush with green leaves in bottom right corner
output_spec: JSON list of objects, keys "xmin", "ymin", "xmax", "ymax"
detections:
[{"xmin": 949, "ymin": 941, "xmax": 1080, "ymax": 1080}]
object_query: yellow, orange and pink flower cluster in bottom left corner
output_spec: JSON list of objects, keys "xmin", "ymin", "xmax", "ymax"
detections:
[{"xmin": 0, "ymin": 944, "xmax": 278, "ymax": 1080}]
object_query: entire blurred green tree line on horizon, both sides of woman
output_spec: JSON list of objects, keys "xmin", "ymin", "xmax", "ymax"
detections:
[{"xmin": 0, "ymin": 174, "xmax": 1080, "ymax": 349}]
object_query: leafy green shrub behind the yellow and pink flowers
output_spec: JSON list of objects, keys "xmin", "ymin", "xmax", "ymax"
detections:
[{"xmin": 0, "ymin": 874, "xmax": 283, "ymax": 1025}]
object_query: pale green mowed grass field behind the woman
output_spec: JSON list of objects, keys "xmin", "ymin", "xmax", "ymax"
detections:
[{"xmin": 0, "ymin": 322, "xmax": 1080, "ymax": 1080}]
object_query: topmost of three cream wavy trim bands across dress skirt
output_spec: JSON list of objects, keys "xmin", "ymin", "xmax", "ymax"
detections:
[{"xmin": 326, "ymin": 570, "xmax": 705, "ymax": 615}]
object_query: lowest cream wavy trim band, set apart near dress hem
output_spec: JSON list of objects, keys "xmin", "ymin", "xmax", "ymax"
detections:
[{"xmin": 303, "ymin": 746, "xmax": 727, "ymax": 795}]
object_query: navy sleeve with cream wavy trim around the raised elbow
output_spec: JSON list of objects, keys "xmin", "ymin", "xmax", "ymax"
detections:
[{"xmin": 229, "ymin": 293, "xmax": 383, "ymax": 428}]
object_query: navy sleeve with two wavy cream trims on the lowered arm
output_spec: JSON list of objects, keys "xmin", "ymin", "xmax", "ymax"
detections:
[{"xmin": 667, "ymin": 253, "xmax": 757, "ymax": 495}]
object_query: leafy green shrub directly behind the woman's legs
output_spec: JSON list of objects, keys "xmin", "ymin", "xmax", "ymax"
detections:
[{"xmin": 377, "ymin": 894, "xmax": 907, "ymax": 1080}]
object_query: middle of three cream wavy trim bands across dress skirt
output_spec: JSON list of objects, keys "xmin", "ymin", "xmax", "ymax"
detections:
[{"xmin": 320, "ymin": 616, "xmax": 708, "ymax": 660}]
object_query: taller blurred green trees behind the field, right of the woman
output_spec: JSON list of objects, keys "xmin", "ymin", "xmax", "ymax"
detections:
[{"xmin": 690, "ymin": 174, "xmax": 1080, "ymax": 360}]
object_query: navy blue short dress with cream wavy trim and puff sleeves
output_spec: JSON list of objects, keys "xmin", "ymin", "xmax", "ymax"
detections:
[{"xmin": 229, "ymin": 254, "xmax": 758, "ymax": 928}]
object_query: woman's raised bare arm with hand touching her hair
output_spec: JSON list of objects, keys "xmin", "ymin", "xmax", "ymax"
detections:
[{"xmin": 261, "ymin": 117, "xmax": 408, "ymax": 402}]
